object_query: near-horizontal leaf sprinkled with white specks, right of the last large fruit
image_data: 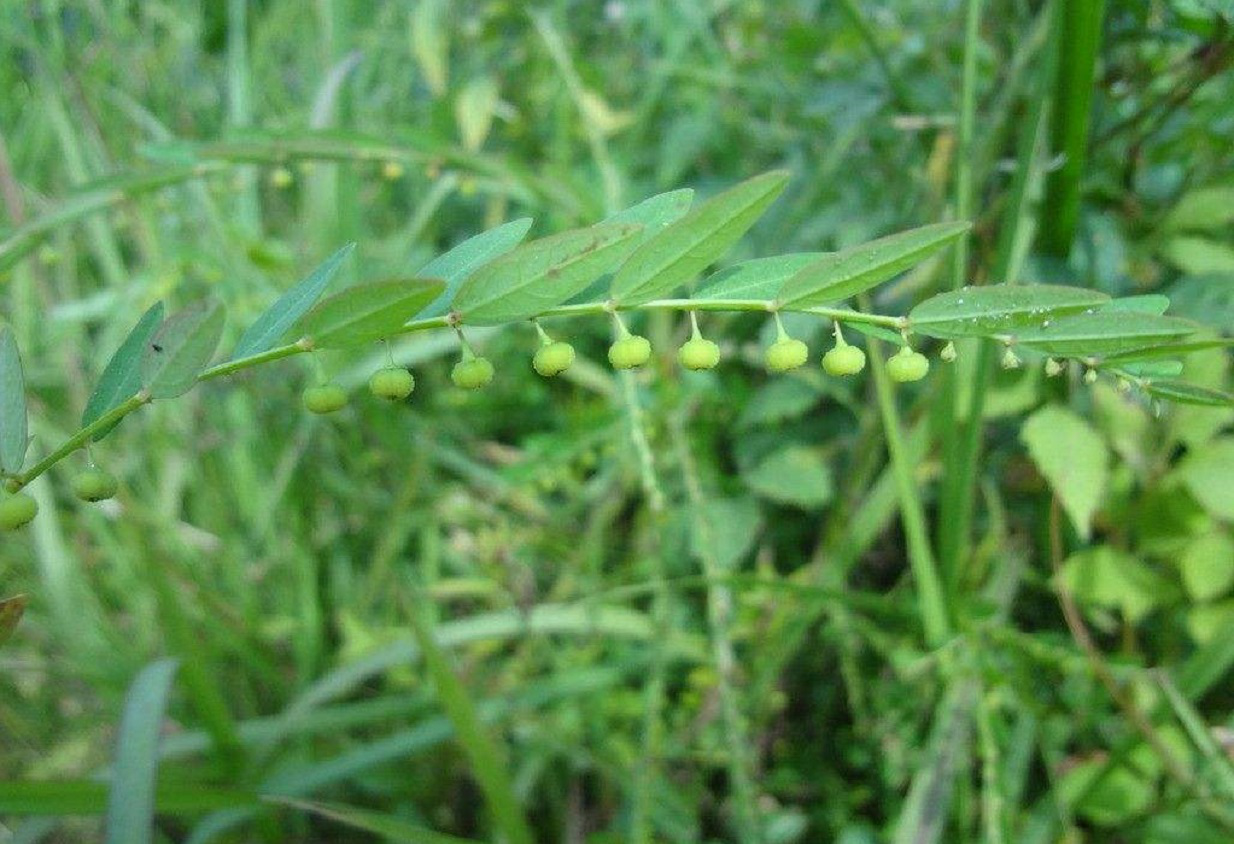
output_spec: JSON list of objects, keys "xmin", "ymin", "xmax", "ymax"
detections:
[{"xmin": 908, "ymin": 284, "xmax": 1109, "ymax": 339}]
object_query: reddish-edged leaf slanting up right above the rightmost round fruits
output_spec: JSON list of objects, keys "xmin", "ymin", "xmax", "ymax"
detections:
[{"xmin": 776, "ymin": 222, "xmax": 971, "ymax": 311}]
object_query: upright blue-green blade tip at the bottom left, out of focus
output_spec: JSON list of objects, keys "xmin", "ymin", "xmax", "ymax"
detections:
[{"xmin": 106, "ymin": 659, "xmax": 176, "ymax": 844}]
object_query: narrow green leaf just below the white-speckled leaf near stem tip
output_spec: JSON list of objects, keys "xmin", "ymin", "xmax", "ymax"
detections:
[{"xmin": 1014, "ymin": 311, "xmax": 1199, "ymax": 358}]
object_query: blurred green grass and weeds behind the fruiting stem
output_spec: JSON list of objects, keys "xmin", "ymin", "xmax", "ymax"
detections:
[{"xmin": 0, "ymin": 0, "xmax": 1234, "ymax": 844}]
